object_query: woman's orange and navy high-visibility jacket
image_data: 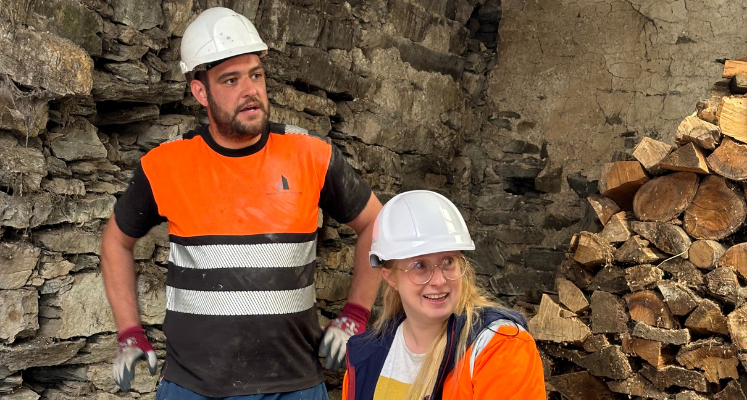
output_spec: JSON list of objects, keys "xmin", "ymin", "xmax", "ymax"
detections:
[{"xmin": 342, "ymin": 310, "xmax": 547, "ymax": 400}]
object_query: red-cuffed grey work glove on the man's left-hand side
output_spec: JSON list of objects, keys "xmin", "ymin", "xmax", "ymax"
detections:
[{"xmin": 113, "ymin": 326, "xmax": 158, "ymax": 392}]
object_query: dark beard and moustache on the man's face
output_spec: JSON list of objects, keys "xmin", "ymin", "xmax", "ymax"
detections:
[{"xmin": 207, "ymin": 90, "xmax": 270, "ymax": 139}]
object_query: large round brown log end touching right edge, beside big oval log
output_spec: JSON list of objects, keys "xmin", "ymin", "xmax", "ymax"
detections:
[{"xmin": 683, "ymin": 175, "xmax": 747, "ymax": 240}]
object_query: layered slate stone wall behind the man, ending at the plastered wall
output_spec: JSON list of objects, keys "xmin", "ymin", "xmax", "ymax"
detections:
[{"xmin": 0, "ymin": 0, "xmax": 508, "ymax": 400}]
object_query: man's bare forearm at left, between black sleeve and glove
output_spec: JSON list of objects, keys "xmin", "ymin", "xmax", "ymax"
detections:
[{"xmin": 101, "ymin": 216, "xmax": 140, "ymax": 332}]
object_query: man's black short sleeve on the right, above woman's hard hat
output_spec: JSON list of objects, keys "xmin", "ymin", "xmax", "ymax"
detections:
[{"xmin": 319, "ymin": 145, "xmax": 371, "ymax": 224}]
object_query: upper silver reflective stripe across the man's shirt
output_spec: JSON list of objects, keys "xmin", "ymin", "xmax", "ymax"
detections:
[{"xmin": 169, "ymin": 240, "xmax": 316, "ymax": 269}]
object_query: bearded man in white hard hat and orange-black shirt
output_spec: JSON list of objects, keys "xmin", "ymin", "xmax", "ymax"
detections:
[{"xmin": 101, "ymin": 8, "xmax": 381, "ymax": 400}]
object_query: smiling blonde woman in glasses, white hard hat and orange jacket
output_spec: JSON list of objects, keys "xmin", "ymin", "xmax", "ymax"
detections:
[{"xmin": 343, "ymin": 190, "xmax": 546, "ymax": 400}]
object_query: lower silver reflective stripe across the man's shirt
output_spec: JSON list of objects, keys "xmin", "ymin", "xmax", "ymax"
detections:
[{"xmin": 166, "ymin": 284, "xmax": 316, "ymax": 315}]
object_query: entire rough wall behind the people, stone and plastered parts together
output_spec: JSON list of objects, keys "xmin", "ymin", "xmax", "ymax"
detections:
[{"xmin": 0, "ymin": 0, "xmax": 747, "ymax": 399}]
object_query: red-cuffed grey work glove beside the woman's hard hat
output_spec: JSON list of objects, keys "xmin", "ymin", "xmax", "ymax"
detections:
[{"xmin": 319, "ymin": 303, "xmax": 371, "ymax": 371}]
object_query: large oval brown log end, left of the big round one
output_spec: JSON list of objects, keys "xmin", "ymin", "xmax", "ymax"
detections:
[{"xmin": 633, "ymin": 172, "xmax": 698, "ymax": 222}]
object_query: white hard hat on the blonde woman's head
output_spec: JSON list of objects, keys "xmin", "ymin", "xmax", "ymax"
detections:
[{"xmin": 368, "ymin": 190, "xmax": 475, "ymax": 267}]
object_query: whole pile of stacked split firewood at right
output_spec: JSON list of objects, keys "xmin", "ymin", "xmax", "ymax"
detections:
[{"xmin": 529, "ymin": 61, "xmax": 747, "ymax": 400}]
